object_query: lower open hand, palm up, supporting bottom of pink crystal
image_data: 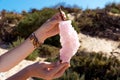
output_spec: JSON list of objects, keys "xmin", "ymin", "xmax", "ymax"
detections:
[{"xmin": 27, "ymin": 62, "xmax": 69, "ymax": 80}]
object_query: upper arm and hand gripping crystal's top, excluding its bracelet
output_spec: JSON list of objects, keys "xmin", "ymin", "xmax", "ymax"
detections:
[{"xmin": 0, "ymin": 14, "xmax": 65, "ymax": 72}]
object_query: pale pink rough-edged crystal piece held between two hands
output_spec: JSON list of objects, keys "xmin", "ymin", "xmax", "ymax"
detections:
[{"xmin": 59, "ymin": 20, "xmax": 80, "ymax": 62}]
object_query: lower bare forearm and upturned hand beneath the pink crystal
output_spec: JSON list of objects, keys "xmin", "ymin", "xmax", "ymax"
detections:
[{"xmin": 7, "ymin": 62, "xmax": 69, "ymax": 80}]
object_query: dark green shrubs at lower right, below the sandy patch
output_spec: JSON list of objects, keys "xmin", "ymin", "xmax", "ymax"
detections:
[{"xmin": 71, "ymin": 54, "xmax": 120, "ymax": 80}]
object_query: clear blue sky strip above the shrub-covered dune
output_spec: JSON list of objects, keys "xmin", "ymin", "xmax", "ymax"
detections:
[{"xmin": 0, "ymin": 0, "xmax": 120, "ymax": 12}]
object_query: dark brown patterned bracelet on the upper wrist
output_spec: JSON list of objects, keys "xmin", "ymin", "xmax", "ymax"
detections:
[{"xmin": 29, "ymin": 33, "xmax": 42, "ymax": 48}]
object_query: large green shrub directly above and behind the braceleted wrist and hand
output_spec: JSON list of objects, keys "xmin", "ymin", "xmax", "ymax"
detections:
[{"xmin": 17, "ymin": 8, "xmax": 56, "ymax": 37}]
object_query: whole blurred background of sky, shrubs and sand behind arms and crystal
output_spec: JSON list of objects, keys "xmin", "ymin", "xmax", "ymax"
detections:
[{"xmin": 0, "ymin": 0, "xmax": 120, "ymax": 80}]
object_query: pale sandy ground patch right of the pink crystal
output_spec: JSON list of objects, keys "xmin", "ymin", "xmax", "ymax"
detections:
[{"xmin": 78, "ymin": 33, "xmax": 120, "ymax": 57}]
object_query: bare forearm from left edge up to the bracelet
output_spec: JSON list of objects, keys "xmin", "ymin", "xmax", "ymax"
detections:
[{"xmin": 0, "ymin": 36, "xmax": 41, "ymax": 72}]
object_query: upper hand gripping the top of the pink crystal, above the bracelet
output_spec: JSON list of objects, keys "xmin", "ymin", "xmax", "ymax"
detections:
[{"xmin": 35, "ymin": 12, "xmax": 66, "ymax": 42}]
